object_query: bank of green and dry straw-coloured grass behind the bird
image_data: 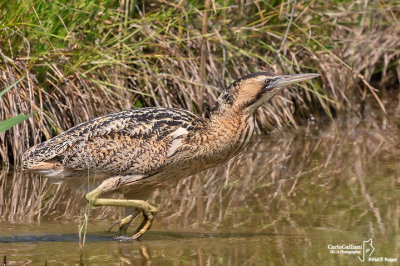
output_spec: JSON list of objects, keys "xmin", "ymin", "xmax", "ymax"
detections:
[{"xmin": 0, "ymin": 0, "xmax": 400, "ymax": 163}]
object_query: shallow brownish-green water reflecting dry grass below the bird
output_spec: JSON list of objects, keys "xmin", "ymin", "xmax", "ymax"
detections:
[{"xmin": 0, "ymin": 108, "xmax": 400, "ymax": 265}]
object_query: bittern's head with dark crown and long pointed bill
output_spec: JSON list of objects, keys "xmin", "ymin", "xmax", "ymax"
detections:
[{"xmin": 212, "ymin": 72, "xmax": 319, "ymax": 114}]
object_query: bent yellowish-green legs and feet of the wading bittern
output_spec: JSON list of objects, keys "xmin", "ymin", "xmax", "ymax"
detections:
[{"xmin": 86, "ymin": 177, "xmax": 157, "ymax": 239}]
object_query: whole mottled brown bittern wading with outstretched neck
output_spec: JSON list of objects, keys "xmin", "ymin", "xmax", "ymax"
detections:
[{"xmin": 22, "ymin": 72, "xmax": 320, "ymax": 239}]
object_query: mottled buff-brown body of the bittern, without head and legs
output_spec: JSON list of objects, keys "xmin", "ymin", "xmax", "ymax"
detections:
[{"xmin": 24, "ymin": 108, "xmax": 253, "ymax": 193}]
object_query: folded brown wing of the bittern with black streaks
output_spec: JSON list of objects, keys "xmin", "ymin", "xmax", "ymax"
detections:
[{"xmin": 26, "ymin": 108, "xmax": 202, "ymax": 174}]
